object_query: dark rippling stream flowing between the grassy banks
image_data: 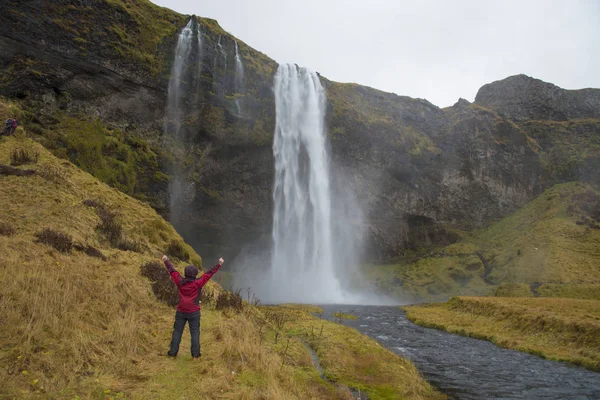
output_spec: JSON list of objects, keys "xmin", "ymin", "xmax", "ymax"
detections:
[{"xmin": 323, "ymin": 305, "xmax": 600, "ymax": 400}]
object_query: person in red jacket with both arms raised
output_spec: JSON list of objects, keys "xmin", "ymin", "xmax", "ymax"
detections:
[{"xmin": 162, "ymin": 256, "xmax": 223, "ymax": 359}]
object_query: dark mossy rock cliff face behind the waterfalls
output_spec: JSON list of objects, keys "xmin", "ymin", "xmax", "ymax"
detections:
[{"xmin": 0, "ymin": 0, "xmax": 600, "ymax": 260}]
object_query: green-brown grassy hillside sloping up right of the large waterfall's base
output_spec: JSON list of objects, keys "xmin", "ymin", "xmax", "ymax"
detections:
[{"xmin": 366, "ymin": 182, "xmax": 600, "ymax": 301}]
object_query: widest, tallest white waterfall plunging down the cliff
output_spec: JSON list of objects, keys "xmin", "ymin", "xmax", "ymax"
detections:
[{"xmin": 261, "ymin": 64, "xmax": 344, "ymax": 303}]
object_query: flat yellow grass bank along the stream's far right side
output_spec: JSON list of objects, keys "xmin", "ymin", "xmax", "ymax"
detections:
[{"xmin": 405, "ymin": 297, "xmax": 600, "ymax": 371}]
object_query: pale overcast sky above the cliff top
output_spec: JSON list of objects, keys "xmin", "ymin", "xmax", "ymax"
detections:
[{"xmin": 152, "ymin": 0, "xmax": 600, "ymax": 107}]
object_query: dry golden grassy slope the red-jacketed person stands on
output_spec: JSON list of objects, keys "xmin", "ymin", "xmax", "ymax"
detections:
[{"xmin": 0, "ymin": 134, "xmax": 440, "ymax": 399}]
